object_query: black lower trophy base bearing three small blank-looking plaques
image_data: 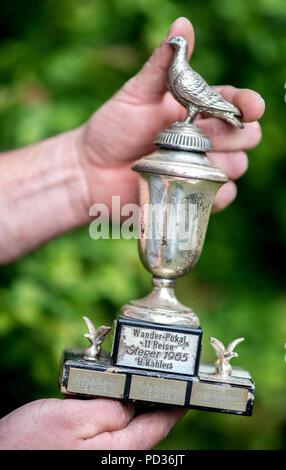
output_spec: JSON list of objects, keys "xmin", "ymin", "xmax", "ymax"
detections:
[{"xmin": 59, "ymin": 349, "xmax": 254, "ymax": 416}]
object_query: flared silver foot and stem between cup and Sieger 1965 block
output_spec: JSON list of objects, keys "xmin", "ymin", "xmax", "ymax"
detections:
[{"xmin": 120, "ymin": 276, "xmax": 200, "ymax": 327}]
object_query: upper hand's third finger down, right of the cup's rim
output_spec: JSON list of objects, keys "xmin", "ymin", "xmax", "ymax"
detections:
[{"xmin": 208, "ymin": 151, "xmax": 248, "ymax": 180}]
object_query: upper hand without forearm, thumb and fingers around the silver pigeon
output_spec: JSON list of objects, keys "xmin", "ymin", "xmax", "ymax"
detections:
[{"xmin": 78, "ymin": 18, "xmax": 264, "ymax": 214}]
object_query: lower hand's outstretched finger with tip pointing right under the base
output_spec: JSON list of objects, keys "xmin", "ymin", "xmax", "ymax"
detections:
[{"xmin": 90, "ymin": 408, "xmax": 186, "ymax": 450}]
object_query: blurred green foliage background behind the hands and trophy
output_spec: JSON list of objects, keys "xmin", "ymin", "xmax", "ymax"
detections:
[{"xmin": 0, "ymin": 0, "xmax": 286, "ymax": 449}]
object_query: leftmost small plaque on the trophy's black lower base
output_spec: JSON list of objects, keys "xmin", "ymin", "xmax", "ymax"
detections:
[{"xmin": 67, "ymin": 367, "xmax": 126, "ymax": 398}]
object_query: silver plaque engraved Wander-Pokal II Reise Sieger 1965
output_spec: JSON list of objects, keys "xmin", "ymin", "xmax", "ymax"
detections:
[{"xmin": 116, "ymin": 325, "xmax": 200, "ymax": 375}]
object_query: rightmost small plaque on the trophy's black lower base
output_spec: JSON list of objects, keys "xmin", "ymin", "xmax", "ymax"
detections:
[{"xmin": 190, "ymin": 382, "xmax": 248, "ymax": 411}]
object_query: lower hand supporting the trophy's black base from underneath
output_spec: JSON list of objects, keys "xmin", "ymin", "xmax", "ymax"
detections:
[{"xmin": 0, "ymin": 398, "xmax": 186, "ymax": 450}]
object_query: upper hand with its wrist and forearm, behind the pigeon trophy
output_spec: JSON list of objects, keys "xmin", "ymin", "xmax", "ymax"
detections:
[{"xmin": 0, "ymin": 18, "xmax": 264, "ymax": 263}]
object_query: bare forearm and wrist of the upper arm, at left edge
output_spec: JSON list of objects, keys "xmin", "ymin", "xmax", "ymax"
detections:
[{"xmin": 0, "ymin": 128, "xmax": 89, "ymax": 263}]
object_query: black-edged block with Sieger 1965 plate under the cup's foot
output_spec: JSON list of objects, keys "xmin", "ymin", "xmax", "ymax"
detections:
[{"xmin": 111, "ymin": 317, "xmax": 202, "ymax": 376}]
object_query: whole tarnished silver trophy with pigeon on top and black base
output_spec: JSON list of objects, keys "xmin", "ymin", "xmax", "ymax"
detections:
[{"xmin": 60, "ymin": 36, "xmax": 254, "ymax": 415}]
